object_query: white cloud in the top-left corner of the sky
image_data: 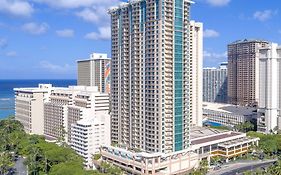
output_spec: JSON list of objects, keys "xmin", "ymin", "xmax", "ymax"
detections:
[{"xmin": 0, "ymin": 0, "xmax": 34, "ymax": 17}]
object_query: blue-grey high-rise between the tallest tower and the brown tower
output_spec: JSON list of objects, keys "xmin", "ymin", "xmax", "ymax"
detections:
[{"xmin": 203, "ymin": 63, "xmax": 227, "ymax": 103}]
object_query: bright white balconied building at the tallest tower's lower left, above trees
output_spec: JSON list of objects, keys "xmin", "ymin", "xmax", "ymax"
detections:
[{"xmin": 71, "ymin": 113, "xmax": 111, "ymax": 168}]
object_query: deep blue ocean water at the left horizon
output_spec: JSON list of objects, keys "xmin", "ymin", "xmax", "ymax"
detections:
[{"xmin": 0, "ymin": 80, "xmax": 77, "ymax": 119}]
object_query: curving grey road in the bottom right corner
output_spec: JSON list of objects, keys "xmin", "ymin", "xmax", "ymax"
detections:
[{"xmin": 207, "ymin": 160, "xmax": 276, "ymax": 175}]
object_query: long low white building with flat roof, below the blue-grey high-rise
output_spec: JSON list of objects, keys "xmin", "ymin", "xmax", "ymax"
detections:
[{"xmin": 203, "ymin": 102, "xmax": 257, "ymax": 127}]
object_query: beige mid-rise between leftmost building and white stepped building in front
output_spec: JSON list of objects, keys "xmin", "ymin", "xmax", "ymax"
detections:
[{"xmin": 44, "ymin": 86, "xmax": 109, "ymax": 143}]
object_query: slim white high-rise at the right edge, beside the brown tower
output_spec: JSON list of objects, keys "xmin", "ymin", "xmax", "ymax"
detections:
[{"xmin": 258, "ymin": 43, "xmax": 281, "ymax": 133}]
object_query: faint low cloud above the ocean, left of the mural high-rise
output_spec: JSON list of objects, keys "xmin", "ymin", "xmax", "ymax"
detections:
[{"xmin": 40, "ymin": 61, "xmax": 74, "ymax": 73}]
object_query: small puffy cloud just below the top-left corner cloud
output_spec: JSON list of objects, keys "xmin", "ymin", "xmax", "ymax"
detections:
[{"xmin": 22, "ymin": 22, "xmax": 49, "ymax": 35}]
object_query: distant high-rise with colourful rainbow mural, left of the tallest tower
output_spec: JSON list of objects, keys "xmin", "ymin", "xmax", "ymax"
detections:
[{"xmin": 77, "ymin": 53, "xmax": 111, "ymax": 93}]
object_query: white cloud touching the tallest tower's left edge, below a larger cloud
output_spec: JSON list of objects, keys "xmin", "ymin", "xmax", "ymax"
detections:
[{"xmin": 85, "ymin": 27, "xmax": 111, "ymax": 40}]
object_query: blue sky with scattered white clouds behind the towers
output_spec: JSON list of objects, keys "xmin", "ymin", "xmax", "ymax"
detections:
[{"xmin": 0, "ymin": 0, "xmax": 281, "ymax": 79}]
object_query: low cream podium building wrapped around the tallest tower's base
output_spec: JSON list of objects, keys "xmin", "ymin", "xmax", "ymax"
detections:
[{"xmin": 101, "ymin": 127, "xmax": 259, "ymax": 175}]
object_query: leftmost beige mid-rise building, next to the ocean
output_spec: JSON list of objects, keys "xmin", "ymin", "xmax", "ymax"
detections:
[{"xmin": 14, "ymin": 84, "xmax": 54, "ymax": 135}]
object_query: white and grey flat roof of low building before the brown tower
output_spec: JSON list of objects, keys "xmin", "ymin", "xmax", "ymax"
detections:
[{"xmin": 203, "ymin": 102, "xmax": 256, "ymax": 115}]
